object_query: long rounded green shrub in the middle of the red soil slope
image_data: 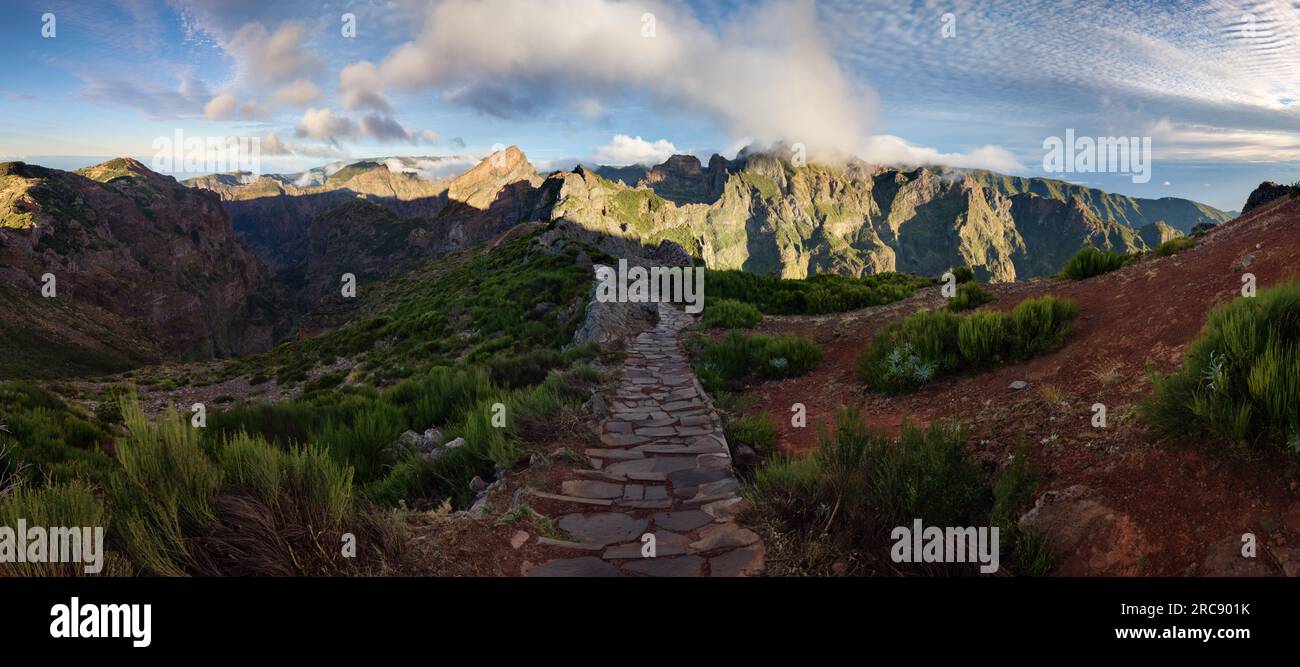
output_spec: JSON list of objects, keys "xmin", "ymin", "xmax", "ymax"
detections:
[{"xmin": 858, "ymin": 296, "xmax": 1079, "ymax": 394}]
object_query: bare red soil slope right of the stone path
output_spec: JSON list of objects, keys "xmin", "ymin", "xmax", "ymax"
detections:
[{"xmin": 753, "ymin": 195, "xmax": 1300, "ymax": 575}]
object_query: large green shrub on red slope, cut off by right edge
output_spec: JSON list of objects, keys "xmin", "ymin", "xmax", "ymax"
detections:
[{"xmin": 1139, "ymin": 281, "xmax": 1300, "ymax": 454}]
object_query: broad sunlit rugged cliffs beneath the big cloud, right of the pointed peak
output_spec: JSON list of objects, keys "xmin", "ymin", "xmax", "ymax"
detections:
[{"xmin": 553, "ymin": 152, "xmax": 1230, "ymax": 281}]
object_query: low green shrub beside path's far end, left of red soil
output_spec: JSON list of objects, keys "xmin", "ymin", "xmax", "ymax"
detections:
[{"xmin": 690, "ymin": 333, "xmax": 822, "ymax": 391}]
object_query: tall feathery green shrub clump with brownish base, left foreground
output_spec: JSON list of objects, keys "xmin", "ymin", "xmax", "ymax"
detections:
[{"xmin": 108, "ymin": 397, "xmax": 400, "ymax": 576}]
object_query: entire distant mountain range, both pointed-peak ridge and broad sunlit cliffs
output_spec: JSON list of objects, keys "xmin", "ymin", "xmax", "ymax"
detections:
[{"xmin": 195, "ymin": 147, "xmax": 1229, "ymax": 293}]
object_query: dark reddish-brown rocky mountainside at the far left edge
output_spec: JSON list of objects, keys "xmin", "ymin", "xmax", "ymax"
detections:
[{"xmin": 0, "ymin": 159, "xmax": 285, "ymax": 371}]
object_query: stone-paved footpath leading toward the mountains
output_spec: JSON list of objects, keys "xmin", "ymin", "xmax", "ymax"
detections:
[{"xmin": 528, "ymin": 303, "xmax": 764, "ymax": 576}]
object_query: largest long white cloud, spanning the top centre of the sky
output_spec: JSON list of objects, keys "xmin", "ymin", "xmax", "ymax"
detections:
[{"xmin": 341, "ymin": 0, "xmax": 876, "ymax": 152}]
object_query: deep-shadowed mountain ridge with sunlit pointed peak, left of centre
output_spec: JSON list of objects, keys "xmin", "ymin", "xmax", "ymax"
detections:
[{"xmin": 186, "ymin": 147, "xmax": 543, "ymax": 304}]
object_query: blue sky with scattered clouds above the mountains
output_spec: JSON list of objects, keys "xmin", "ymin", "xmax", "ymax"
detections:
[{"xmin": 0, "ymin": 0, "xmax": 1300, "ymax": 209}]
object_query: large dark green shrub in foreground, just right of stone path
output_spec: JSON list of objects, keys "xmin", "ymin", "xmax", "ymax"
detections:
[{"xmin": 746, "ymin": 408, "xmax": 1050, "ymax": 573}]
